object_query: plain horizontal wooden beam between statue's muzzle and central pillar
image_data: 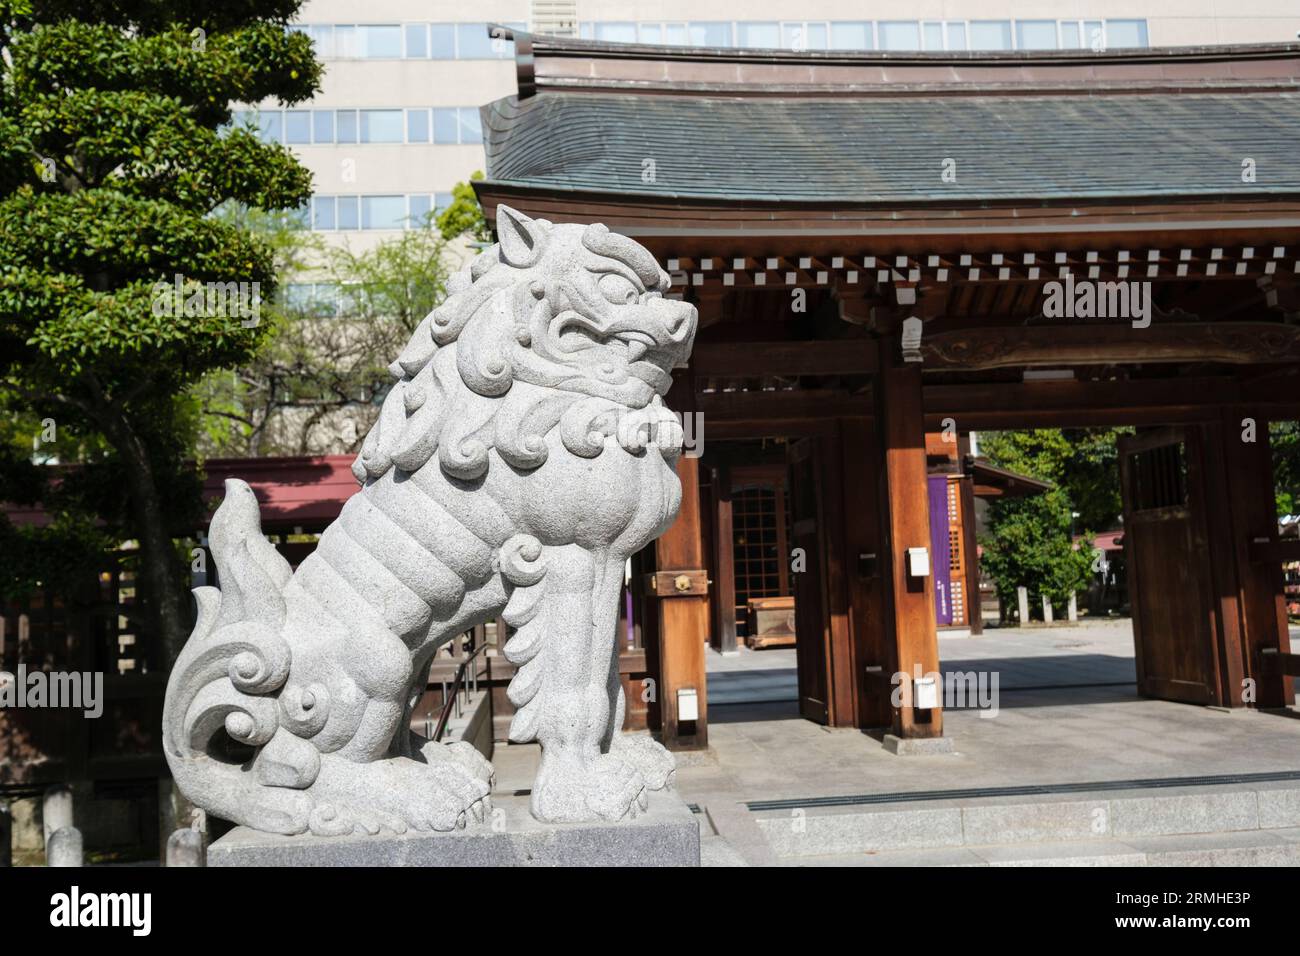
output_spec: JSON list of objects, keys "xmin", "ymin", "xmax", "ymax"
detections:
[{"xmin": 690, "ymin": 338, "xmax": 878, "ymax": 378}]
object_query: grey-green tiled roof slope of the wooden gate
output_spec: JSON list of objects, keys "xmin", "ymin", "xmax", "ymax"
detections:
[{"xmin": 482, "ymin": 91, "xmax": 1300, "ymax": 206}]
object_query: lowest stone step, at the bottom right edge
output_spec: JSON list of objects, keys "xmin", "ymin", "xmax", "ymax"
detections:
[{"xmin": 780, "ymin": 827, "xmax": 1300, "ymax": 866}]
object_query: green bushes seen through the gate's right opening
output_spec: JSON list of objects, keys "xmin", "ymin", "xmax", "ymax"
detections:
[{"xmin": 979, "ymin": 428, "xmax": 1127, "ymax": 621}]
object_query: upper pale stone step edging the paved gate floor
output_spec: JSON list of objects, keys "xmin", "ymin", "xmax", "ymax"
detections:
[{"xmin": 753, "ymin": 784, "xmax": 1300, "ymax": 857}]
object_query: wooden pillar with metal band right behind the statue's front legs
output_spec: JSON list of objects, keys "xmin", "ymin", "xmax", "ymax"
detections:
[{"xmin": 645, "ymin": 455, "xmax": 709, "ymax": 750}]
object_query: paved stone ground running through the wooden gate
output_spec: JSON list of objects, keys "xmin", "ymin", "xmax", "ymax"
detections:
[{"xmin": 494, "ymin": 622, "xmax": 1300, "ymax": 862}]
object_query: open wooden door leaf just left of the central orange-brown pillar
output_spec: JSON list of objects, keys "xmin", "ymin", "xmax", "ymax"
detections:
[{"xmin": 784, "ymin": 438, "xmax": 831, "ymax": 723}]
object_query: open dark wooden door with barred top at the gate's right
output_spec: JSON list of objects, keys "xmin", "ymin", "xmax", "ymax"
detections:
[{"xmin": 1119, "ymin": 427, "xmax": 1219, "ymax": 704}]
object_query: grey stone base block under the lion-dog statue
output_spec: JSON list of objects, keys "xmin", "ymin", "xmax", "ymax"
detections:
[{"xmin": 208, "ymin": 791, "xmax": 699, "ymax": 868}]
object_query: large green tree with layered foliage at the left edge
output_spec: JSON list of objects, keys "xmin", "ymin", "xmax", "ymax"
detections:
[{"xmin": 0, "ymin": 0, "xmax": 320, "ymax": 654}]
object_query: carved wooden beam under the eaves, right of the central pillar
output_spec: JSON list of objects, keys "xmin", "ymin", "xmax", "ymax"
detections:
[{"xmin": 920, "ymin": 320, "xmax": 1300, "ymax": 371}]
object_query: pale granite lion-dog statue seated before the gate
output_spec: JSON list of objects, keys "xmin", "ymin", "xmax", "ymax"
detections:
[{"xmin": 164, "ymin": 206, "xmax": 697, "ymax": 835}]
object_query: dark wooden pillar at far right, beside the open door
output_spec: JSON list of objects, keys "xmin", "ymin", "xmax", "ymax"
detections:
[{"xmin": 1222, "ymin": 407, "xmax": 1295, "ymax": 708}]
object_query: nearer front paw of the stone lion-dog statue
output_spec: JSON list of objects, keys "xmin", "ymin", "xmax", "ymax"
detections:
[{"xmin": 532, "ymin": 753, "xmax": 649, "ymax": 823}]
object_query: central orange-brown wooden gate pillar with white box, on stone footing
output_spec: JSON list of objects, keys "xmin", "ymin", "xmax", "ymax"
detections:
[{"xmin": 875, "ymin": 348, "xmax": 944, "ymax": 737}]
